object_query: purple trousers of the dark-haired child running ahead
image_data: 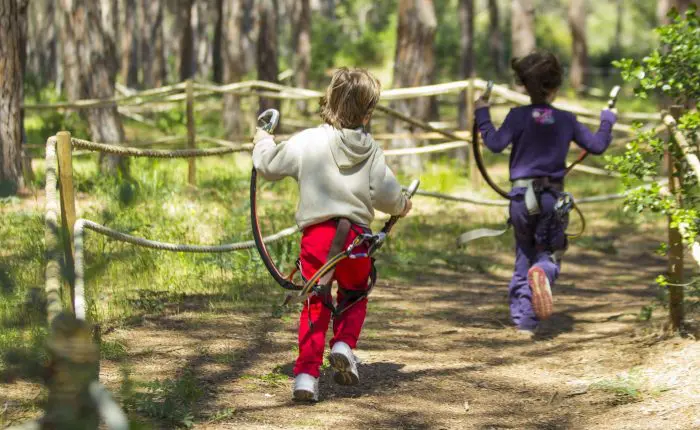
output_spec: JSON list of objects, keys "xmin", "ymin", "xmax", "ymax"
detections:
[{"xmin": 508, "ymin": 188, "xmax": 567, "ymax": 330}]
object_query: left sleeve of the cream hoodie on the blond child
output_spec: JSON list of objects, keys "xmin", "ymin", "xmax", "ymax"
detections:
[{"xmin": 253, "ymin": 136, "xmax": 301, "ymax": 181}]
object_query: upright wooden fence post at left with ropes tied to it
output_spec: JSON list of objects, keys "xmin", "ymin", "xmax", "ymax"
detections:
[{"xmin": 56, "ymin": 131, "xmax": 76, "ymax": 311}]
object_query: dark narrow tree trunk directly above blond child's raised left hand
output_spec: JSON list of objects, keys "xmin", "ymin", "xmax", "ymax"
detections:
[{"xmin": 257, "ymin": 0, "xmax": 280, "ymax": 112}]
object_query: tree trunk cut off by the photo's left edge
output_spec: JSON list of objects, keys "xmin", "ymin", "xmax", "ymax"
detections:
[{"xmin": 0, "ymin": 0, "xmax": 24, "ymax": 196}]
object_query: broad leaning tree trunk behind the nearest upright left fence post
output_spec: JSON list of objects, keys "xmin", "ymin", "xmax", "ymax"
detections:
[{"xmin": 61, "ymin": 0, "xmax": 126, "ymax": 171}]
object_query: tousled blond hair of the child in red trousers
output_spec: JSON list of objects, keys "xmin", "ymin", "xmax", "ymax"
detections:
[{"xmin": 321, "ymin": 67, "xmax": 382, "ymax": 129}]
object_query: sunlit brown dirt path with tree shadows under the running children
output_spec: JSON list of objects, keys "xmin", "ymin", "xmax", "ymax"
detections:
[{"xmin": 91, "ymin": 227, "xmax": 700, "ymax": 429}]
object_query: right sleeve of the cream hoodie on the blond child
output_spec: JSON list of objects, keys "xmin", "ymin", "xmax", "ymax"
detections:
[{"xmin": 369, "ymin": 149, "xmax": 406, "ymax": 215}]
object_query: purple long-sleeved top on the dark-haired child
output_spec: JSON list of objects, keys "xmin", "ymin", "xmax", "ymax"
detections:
[{"xmin": 476, "ymin": 104, "xmax": 617, "ymax": 181}]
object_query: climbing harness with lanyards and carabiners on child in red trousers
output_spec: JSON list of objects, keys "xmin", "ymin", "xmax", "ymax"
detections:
[{"xmin": 250, "ymin": 109, "xmax": 420, "ymax": 314}]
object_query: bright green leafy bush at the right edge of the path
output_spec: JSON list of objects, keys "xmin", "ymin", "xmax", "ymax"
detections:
[{"xmin": 608, "ymin": 6, "xmax": 700, "ymax": 320}]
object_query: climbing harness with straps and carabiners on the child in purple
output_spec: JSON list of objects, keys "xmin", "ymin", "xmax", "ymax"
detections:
[{"xmin": 457, "ymin": 81, "xmax": 620, "ymax": 247}]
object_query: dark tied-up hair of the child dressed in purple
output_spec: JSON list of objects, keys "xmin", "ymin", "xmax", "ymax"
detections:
[{"xmin": 511, "ymin": 51, "xmax": 563, "ymax": 103}]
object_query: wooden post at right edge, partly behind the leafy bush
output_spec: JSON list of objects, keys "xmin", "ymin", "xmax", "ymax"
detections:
[{"xmin": 667, "ymin": 106, "xmax": 684, "ymax": 332}]
